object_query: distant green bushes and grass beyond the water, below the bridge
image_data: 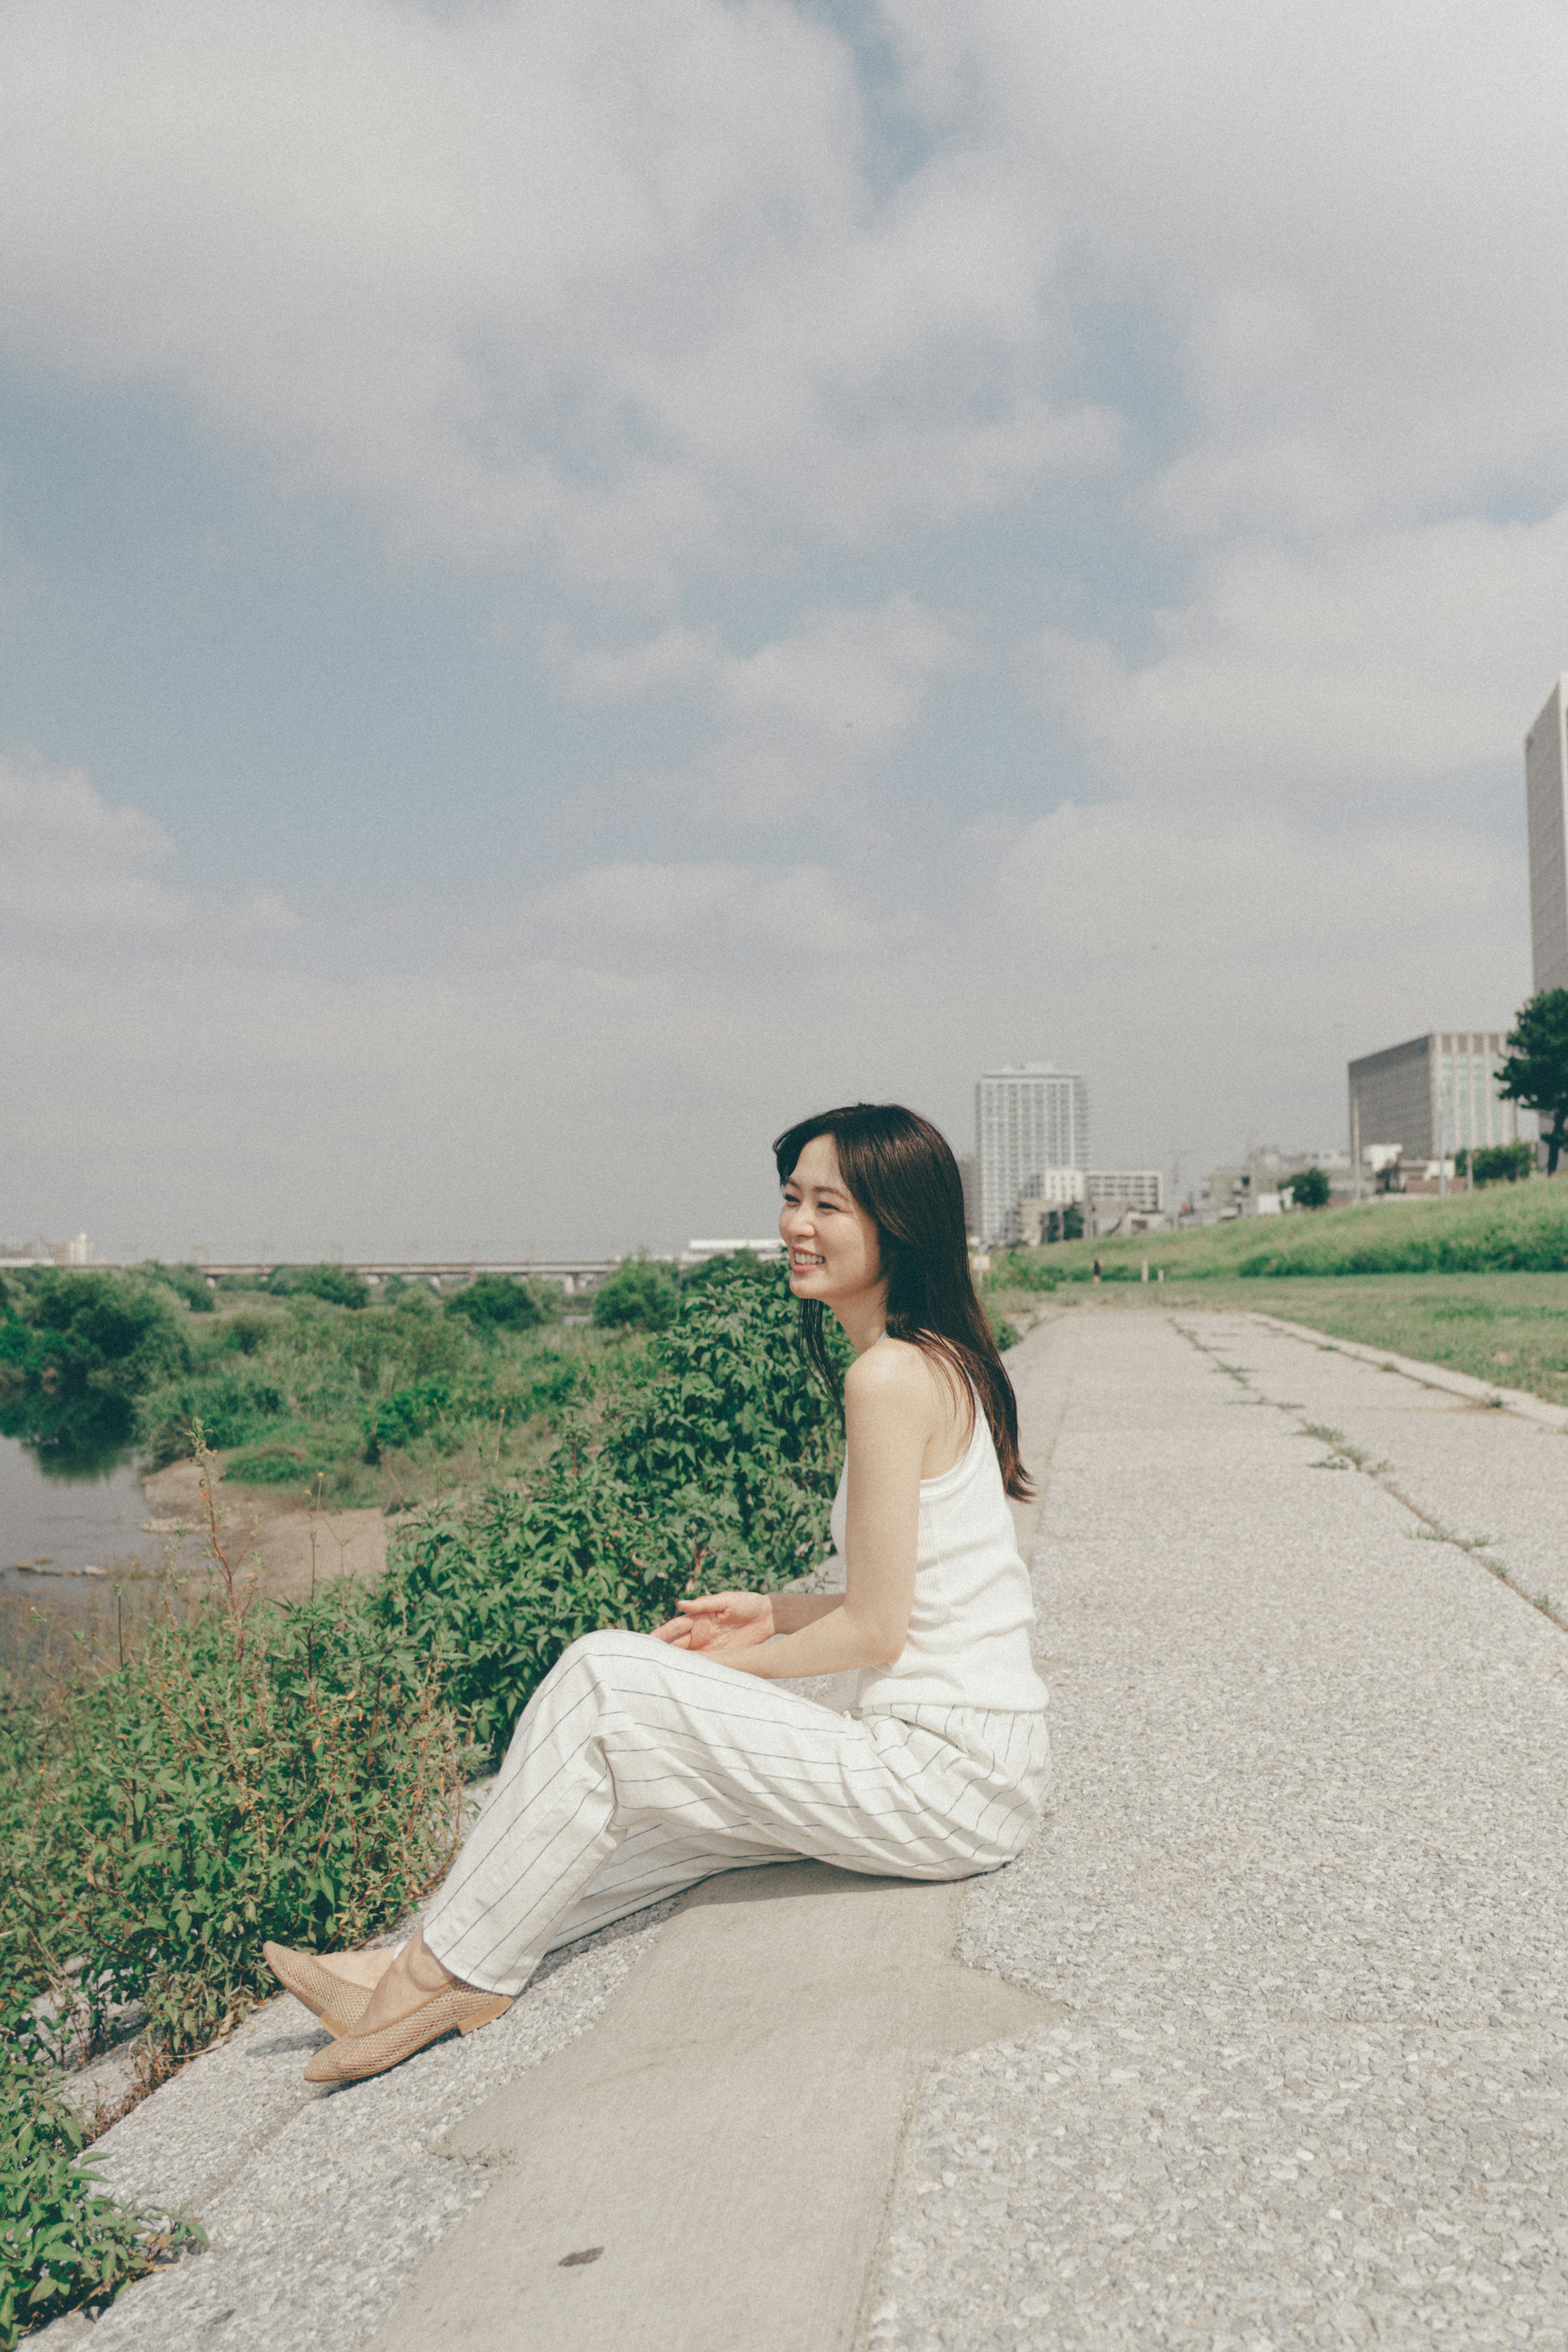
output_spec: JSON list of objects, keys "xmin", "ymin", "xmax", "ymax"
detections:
[{"xmin": 0, "ymin": 1265, "xmax": 606, "ymax": 1508}]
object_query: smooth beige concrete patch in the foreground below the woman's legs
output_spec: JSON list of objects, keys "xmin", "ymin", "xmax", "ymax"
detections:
[{"xmin": 376, "ymin": 1863, "xmax": 1062, "ymax": 2352}]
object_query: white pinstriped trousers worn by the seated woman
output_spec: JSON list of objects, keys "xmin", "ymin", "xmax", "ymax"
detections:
[{"xmin": 425, "ymin": 1632, "xmax": 1051, "ymax": 1992}]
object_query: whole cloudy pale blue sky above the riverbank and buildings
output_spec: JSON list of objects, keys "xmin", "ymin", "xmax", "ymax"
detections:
[{"xmin": 0, "ymin": 0, "xmax": 1568, "ymax": 1256}]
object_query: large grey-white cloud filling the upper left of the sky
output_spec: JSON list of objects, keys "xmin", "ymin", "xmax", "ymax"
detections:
[{"xmin": 0, "ymin": 0, "xmax": 1109, "ymax": 586}]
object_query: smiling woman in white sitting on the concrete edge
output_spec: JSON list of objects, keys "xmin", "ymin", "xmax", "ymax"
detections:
[{"xmin": 266, "ymin": 1103, "xmax": 1049, "ymax": 2082}]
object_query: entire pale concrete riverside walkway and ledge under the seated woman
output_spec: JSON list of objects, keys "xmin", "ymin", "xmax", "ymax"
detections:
[{"xmin": 38, "ymin": 1301, "xmax": 1568, "ymax": 2352}]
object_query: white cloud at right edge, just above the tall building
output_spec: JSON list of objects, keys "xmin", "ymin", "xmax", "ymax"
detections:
[{"xmin": 1034, "ymin": 508, "xmax": 1568, "ymax": 821}]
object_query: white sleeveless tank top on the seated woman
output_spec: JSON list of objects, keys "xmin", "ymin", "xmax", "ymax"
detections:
[{"xmin": 828, "ymin": 1397, "xmax": 1049, "ymax": 1714}]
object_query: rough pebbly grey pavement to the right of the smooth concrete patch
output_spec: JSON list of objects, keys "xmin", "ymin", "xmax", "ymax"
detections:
[{"xmin": 870, "ymin": 1301, "xmax": 1568, "ymax": 2352}]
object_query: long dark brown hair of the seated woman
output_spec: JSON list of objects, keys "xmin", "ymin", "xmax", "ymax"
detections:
[{"xmin": 773, "ymin": 1103, "xmax": 1034, "ymax": 1503}]
